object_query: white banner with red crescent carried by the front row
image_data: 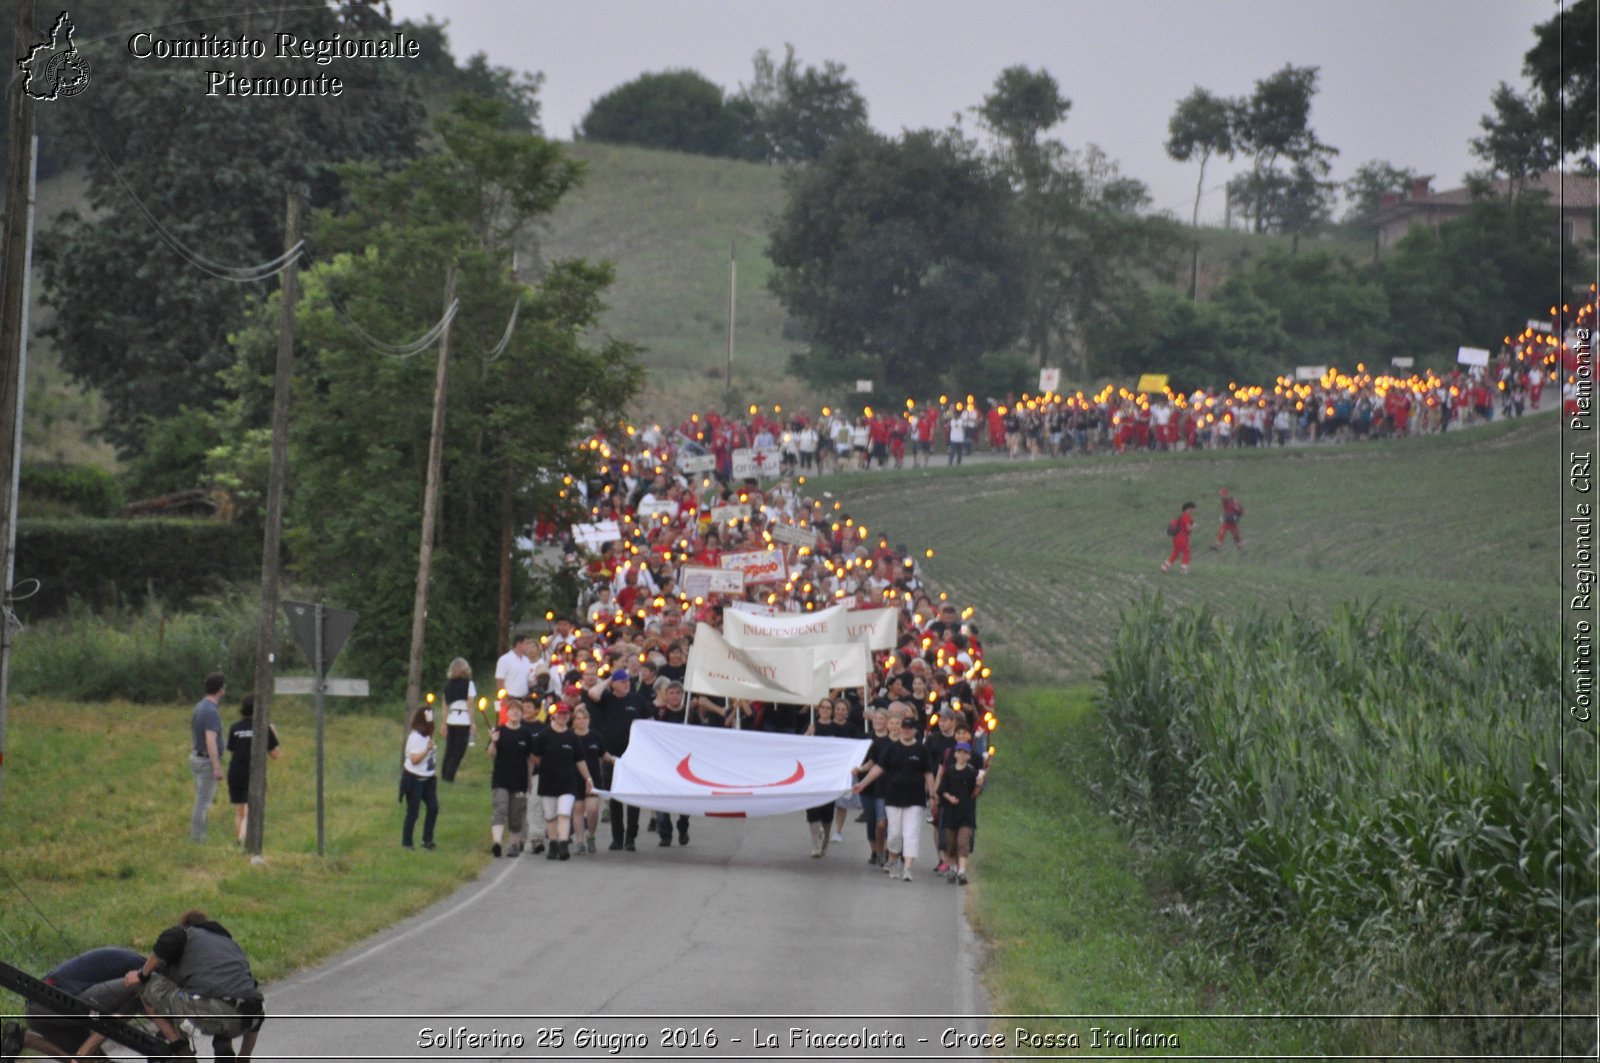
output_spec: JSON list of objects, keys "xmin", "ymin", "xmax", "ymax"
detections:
[{"xmin": 602, "ymin": 720, "xmax": 872, "ymax": 816}]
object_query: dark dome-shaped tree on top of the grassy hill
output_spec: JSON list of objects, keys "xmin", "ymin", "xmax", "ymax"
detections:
[{"xmin": 578, "ymin": 70, "xmax": 741, "ymax": 157}]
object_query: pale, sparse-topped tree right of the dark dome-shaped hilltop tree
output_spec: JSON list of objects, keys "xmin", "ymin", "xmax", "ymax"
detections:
[{"xmin": 731, "ymin": 45, "xmax": 867, "ymax": 163}]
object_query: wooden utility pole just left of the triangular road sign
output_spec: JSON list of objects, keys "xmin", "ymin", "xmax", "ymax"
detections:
[{"xmin": 245, "ymin": 187, "xmax": 304, "ymax": 855}]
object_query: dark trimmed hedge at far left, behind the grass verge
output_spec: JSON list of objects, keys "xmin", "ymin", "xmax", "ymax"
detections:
[{"xmin": 16, "ymin": 517, "xmax": 261, "ymax": 621}]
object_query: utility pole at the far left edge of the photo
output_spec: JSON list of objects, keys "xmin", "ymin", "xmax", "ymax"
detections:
[{"xmin": 0, "ymin": 0, "xmax": 38, "ymax": 816}]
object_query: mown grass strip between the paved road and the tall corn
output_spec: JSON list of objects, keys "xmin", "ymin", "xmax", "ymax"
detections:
[{"xmin": 968, "ymin": 685, "xmax": 1328, "ymax": 1055}]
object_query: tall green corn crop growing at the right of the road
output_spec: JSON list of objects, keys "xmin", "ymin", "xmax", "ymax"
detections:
[{"xmin": 1101, "ymin": 599, "xmax": 1600, "ymax": 1053}]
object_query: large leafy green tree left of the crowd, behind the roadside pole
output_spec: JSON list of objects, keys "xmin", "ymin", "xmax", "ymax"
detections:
[{"xmin": 234, "ymin": 99, "xmax": 640, "ymax": 692}]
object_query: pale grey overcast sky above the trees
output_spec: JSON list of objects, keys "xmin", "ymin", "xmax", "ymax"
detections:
[{"xmin": 392, "ymin": 0, "xmax": 1560, "ymax": 221}]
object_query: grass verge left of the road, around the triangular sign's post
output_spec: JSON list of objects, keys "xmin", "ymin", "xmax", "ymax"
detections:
[{"xmin": 0, "ymin": 698, "xmax": 488, "ymax": 1010}]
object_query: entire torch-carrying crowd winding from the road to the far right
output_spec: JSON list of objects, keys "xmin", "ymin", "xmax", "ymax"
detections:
[{"xmin": 403, "ymin": 294, "xmax": 1594, "ymax": 882}]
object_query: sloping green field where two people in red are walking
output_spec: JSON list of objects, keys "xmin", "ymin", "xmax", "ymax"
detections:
[{"xmin": 830, "ymin": 408, "xmax": 1562, "ymax": 679}]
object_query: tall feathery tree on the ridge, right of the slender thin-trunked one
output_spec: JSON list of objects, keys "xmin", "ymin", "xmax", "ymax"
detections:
[{"xmin": 1227, "ymin": 66, "xmax": 1339, "ymax": 237}]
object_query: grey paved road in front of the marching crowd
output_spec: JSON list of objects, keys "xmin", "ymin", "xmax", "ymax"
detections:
[{"xmin": 259, "ymin": 813, "xmax": 986, "ymax": 1060}]
